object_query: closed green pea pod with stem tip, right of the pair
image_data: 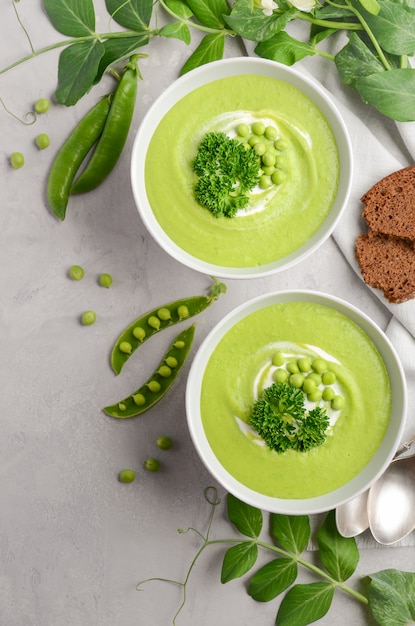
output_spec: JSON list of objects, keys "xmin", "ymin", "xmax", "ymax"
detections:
[{"xmin": 70, "ymin": 54, "xmax": 140, "ymax": 193}]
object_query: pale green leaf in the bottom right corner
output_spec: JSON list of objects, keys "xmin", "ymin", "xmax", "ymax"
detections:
[{"xmin": 368, "ymin": 569, "xmax": 415, "ymax": 626}]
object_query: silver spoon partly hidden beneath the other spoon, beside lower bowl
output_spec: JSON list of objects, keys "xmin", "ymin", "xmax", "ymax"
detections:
[{"xmin": 336, "ymin": 439, "xmax": 415, "ymax": 537}]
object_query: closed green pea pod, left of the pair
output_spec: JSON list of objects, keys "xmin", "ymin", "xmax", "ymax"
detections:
[{"xmin": 47, "ymin": 94, "xmax": 112, "ymax": 220}]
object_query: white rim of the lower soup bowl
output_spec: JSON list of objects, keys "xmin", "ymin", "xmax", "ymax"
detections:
[{"xmin": 185, "ymin": 289, "xmax": 407, "ymax": 515}]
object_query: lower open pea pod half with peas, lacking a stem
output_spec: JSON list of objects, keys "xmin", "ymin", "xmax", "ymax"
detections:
[{"xmin": 102, "ymin": 324, "xmax": 196, "ymax": 419}]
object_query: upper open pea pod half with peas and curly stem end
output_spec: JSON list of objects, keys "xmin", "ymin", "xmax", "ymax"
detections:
[{"xmin": 111, "ymin": 278, "xmax": 226, "ymax": 374}]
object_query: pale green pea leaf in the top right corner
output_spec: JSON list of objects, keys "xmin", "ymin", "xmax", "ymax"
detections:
[{"xmin": 363, "ymin": 0, "xmax": 415, "ymax": 55}]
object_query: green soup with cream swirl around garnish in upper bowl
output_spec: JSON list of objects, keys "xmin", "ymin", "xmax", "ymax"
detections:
[{"xmin": 145, "ymin": 74, "xmax": 339, "ymax": 268}]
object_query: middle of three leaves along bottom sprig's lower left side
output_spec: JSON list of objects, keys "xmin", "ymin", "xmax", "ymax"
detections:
[{"xmin": 248, "ymin": 557, "xmax": 298, "ymax": 602}]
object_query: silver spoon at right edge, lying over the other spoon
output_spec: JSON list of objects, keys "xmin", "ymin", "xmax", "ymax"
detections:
[{"xmin": 367, "ymin": 440, "xmax": 415, "ymax": 545}]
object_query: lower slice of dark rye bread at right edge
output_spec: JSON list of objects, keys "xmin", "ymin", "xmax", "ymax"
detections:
[{"xmin": 356, "ymin": 231, "xmax": 415, "ymax": 304}]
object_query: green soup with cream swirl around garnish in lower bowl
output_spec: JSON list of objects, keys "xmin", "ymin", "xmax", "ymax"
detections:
[{"xmin": 200, "ymin": 302, "xmax": 391, "ymax": 499}]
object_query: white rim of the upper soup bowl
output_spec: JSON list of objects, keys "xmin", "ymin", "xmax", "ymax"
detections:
[{"xmin": 131, "ymin": 57, "xmax": 352, "ymax": 278}]
